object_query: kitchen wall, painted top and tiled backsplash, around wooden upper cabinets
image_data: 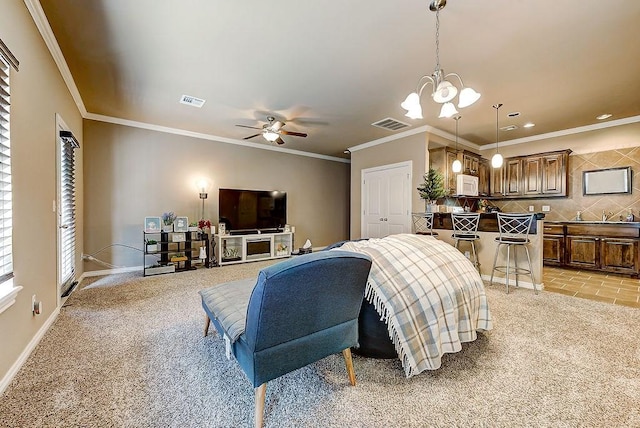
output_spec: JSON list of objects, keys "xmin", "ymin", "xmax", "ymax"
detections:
[{"xmin": 482, "ymin": 123, "xmax": 640, "ymax": 221}]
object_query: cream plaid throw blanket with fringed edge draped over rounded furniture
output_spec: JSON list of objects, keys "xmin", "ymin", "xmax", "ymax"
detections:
[{"xmin": 340, "ymin": 234, "xmax": 492, "ymax": 377}]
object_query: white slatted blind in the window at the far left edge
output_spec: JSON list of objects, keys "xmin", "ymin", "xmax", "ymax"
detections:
[{"xmin": 0, "ymin": 56, "xmax": 13, "ymax": 283}]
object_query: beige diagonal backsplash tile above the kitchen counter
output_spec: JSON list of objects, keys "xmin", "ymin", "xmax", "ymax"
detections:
[{"xmin": 492, "ymin": 147, "xmax": 640, "ymax": 221}]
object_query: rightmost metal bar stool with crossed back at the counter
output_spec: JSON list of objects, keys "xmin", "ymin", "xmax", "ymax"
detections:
[{"xmin": 490, "ymin": 213, "xmax": 538, "ymax": 294}]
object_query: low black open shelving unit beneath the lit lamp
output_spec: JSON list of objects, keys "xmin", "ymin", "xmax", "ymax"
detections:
[{"xmin": 143, "ymin": 232, "xmax": 211, "ymax": 276}]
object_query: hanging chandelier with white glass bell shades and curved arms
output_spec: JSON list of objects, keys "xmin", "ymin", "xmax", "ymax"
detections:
[{"xmin": 401, "ymin": 0, "xmax": 480, "ymax": 119}]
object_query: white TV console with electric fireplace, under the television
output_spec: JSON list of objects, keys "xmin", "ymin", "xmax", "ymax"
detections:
[{"xmin": 214, "ymin": 232, "xmax": 293, "ymax": 266}]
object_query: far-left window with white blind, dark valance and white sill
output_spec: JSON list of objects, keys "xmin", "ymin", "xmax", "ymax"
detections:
[{"xmin": 0, "ymin": 40, "xmax": 22, "ymax": 313}]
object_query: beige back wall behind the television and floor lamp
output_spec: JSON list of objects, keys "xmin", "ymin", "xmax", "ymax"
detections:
[{"xmin": 84, "ymin": 120, "xmax": 349, "ymax": 271}]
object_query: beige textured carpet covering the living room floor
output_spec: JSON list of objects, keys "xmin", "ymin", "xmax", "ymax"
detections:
[{"xmin": 0, "ymin": 263, "xmax": 640, "ymax": 427}]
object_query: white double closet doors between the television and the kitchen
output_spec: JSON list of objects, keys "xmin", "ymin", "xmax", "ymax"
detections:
[{"xmin": 360, "ymin": 161, "xmax": 412, "ymax": 238}]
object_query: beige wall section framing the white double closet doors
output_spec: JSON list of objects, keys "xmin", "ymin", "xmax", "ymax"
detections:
[{"xmin": 351, "ymin": 134, "xmax": 429, "ymax": 239}]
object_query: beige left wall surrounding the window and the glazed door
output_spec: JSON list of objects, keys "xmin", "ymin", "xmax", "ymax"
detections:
[{"xmin": 0, "ymin": 1, "xmax": 83, "ymax": 379}]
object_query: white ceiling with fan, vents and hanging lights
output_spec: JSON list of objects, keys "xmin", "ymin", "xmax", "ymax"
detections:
[{"xmin": 36, "ymin": 0, "xmax": 640, "ymax": 157}]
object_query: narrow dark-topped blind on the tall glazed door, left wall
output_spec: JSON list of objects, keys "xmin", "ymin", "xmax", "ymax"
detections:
[{"xmin": 60, "ymin": 131, "xmax": 80, "ymax": 294}]
